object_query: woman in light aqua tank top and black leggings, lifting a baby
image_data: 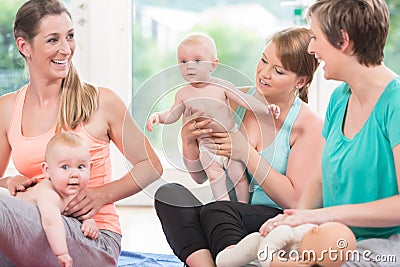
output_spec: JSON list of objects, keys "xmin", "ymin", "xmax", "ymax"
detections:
[{"xmin": 155, "ymin": 28, "xmax": 323, "ymax": 267}]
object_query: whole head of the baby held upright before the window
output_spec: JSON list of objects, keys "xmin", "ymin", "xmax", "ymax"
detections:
[{"xmin": 177, "ymin": 32, "xmax": 218, "ymax": 82}]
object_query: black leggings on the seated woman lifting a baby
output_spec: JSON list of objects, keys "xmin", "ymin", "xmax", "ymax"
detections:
[{"xmin": 155, "ymin": 184, "xmax": 282, "ymax": 262}]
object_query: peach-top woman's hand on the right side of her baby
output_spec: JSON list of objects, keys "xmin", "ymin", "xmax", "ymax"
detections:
[{"xmin": 63, "ymin": 187, "xmax": 106, "ymax": 220}]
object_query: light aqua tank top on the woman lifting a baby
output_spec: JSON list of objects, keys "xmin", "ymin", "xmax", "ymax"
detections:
[{"xmin": 236, "ymin": 88, "xmax": 302, "ymax": 209}]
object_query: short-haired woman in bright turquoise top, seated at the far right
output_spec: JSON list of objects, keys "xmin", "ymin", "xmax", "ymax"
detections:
[{"xmin": 263, "ymin": 0, "xmax": 400, "ymax": 266}]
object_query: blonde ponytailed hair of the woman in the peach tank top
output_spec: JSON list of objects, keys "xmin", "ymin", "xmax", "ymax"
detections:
[{"xmin": 14, "ymin": 0, "xmax": 98, "ymax": 132}]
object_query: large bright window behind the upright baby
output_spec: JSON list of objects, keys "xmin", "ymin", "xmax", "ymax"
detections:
[{"xmin": 132, "ymin": 0, "xmax": 293, "ymax": 170}]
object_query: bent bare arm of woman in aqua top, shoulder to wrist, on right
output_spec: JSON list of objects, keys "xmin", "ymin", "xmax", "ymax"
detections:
[{"xmin": 247, "ymin": 111, "xmax": 324, "ymax": 208}]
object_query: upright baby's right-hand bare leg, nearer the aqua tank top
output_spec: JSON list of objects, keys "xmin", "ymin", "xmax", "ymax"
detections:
[{"xmin": 227, "ymin": 160, "xmax": 250, "ymax": 203}]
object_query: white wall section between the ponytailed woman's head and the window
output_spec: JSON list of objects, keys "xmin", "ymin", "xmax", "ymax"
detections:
[{"xmin": 71, "ymin": 0, "xmax": 132, "ymax": 104}]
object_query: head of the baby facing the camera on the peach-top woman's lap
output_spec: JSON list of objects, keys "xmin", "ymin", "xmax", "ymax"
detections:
[{"xmin": 42, "ymin": 132, "xmax": 91, "ymax": 195}]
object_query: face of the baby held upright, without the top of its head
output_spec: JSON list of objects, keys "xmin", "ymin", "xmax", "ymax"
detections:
[{"xmin": 178, "ymin": 43, "xmax": 216, "ymax": 82}]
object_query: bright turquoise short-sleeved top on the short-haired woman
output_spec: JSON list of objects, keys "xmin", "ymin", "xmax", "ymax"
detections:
[{"xmin": 322, "ymin": 77, "xmax": 400, "ymax": 239}]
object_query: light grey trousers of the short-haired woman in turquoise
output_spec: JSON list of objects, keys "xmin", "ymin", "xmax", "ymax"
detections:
[{"xmin": 342, "ymin": 234, "xmax": 400, "ymax": 267}]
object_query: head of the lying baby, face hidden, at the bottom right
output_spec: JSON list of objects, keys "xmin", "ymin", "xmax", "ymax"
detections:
[{"xmin": 299, "ymin": 222, "xmax": 356, "ymax": 267}]
